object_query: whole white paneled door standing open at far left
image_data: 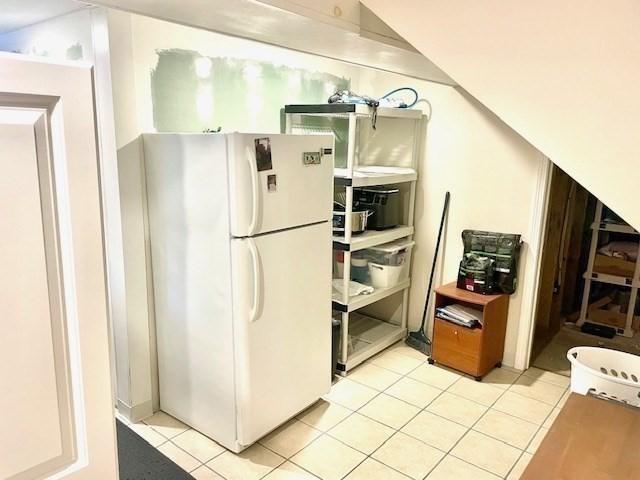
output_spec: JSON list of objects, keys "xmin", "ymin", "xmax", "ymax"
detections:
[{"xmin": 0, "ymin": 54, "xmax": 117, "ymax": 480}]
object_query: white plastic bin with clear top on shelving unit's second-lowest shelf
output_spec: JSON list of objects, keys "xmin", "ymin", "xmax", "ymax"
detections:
[{"xmin": 367, "ymin": 240, "xmax": 415, "ymax": 288}]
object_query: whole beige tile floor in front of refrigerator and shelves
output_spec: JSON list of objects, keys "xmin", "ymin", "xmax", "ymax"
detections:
[{"xmin": 122, "ymin": 343, "xmax": 569, "ymax": 480}]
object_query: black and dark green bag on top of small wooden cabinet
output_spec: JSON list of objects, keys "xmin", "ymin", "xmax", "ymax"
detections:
[{"xmin": 458, "ymin": 230, "xmax": 522, "ymax": 294}]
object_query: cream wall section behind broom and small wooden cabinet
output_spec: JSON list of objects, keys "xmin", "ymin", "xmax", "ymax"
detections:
[{"xmin": 359, "ymin": 70, "xmax": 544, "ymax": 366}]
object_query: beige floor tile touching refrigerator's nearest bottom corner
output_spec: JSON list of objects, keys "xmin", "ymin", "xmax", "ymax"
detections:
[{"xmin": 207, "ymin": 443, "xmax": 284, "ymax": 480}]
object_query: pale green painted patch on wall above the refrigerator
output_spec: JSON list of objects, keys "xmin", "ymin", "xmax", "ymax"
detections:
[{"xmin": 151, "ymin": 49, "xmax": 351, "ymax": 132}]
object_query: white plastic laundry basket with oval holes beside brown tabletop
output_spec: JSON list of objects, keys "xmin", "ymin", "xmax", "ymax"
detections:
[{"xmin": 567, "ymin": 347, "xmax": 640, "ymax": 407}]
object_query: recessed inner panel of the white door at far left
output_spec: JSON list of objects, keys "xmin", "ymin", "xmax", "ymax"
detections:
[{"xmin": 0, "ymin": 117, "xmax": 73, "ymax": 478}]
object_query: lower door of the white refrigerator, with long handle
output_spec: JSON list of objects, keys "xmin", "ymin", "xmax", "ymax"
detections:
[{"xmin": 231, "ymin": 222, "xmax": 331, "ymax": 446}]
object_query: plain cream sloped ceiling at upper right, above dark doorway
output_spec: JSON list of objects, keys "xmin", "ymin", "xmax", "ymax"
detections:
[{"xmin": 362, "ymin": 0, "xmax": 640, "ymax": 229}]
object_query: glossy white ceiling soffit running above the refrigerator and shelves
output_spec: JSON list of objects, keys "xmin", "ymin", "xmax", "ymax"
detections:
[{"xmin": 92, "ymin": 0, "xmax": 453, "ymax": 85}]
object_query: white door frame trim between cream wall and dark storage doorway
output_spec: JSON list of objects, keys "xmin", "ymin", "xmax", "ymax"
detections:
[{"xmin": 514, "ymin": 154, "xmax": 553, "ymax": 370}]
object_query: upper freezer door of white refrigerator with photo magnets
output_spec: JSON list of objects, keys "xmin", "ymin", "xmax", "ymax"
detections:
[{"xmin": 228, "ymin": 133, "xmax": 333, "ymax": 237}]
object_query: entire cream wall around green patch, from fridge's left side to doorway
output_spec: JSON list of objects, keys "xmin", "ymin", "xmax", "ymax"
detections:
[{"xmin": 109, "ymin": 12, "xmax": 542, "ymax": 414}]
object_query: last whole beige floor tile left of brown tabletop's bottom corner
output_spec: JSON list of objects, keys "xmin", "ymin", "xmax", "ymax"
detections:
[{"xmin": 451, "ymin": 430, "xmax": 522, "ymax": 477}]
